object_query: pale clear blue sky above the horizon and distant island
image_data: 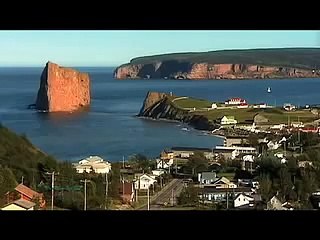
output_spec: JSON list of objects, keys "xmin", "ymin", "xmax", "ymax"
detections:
[{"xmin": 0, "ymin": 30, "xmax": 320, "ymax": 67}]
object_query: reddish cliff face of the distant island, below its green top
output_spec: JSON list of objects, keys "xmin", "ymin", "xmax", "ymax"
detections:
[{"xmin": 114, "ymin": 60, "xmax": 317, "ymax": 79}]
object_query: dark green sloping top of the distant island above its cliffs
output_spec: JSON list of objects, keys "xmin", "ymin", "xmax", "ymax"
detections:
[{"xmin": 130, "ymin": 48, "xmax": 320, "ymax": 69}]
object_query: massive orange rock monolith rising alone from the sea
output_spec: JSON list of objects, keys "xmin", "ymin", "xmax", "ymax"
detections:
[{"xmin": 35, "ymin": 62, "xmax": 90, "ymax": 112}]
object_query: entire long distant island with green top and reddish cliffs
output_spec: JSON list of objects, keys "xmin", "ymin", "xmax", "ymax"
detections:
[{"xmin": 114, "ymin": 48, "xmax": 320, "ymax": 79}]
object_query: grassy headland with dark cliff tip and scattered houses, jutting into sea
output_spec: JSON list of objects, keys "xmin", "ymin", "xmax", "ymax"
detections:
[{"xmin": 138, "ymin": 92, "xmax": 319, "ymax": 132}]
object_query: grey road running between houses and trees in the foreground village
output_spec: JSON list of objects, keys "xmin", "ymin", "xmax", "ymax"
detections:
[{"xmin": 141, "ymin": 179, "xmax": 183, "ymax": 210}]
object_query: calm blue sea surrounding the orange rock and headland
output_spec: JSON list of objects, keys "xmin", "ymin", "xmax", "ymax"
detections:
[{"xmin": 0, "ymin": 68, "xmax": 320, "ymax": 161}]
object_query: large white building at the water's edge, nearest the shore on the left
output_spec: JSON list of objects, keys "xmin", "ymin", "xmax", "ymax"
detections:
[{"xmin": 73, "ymin": 156, "xmax": 111, "ymax": 174}]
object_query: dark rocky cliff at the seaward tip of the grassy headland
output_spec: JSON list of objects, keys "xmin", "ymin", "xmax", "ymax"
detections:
[{"xmin": 138, "ymin": 92, "xmax": 219, "ymax": 130}]
